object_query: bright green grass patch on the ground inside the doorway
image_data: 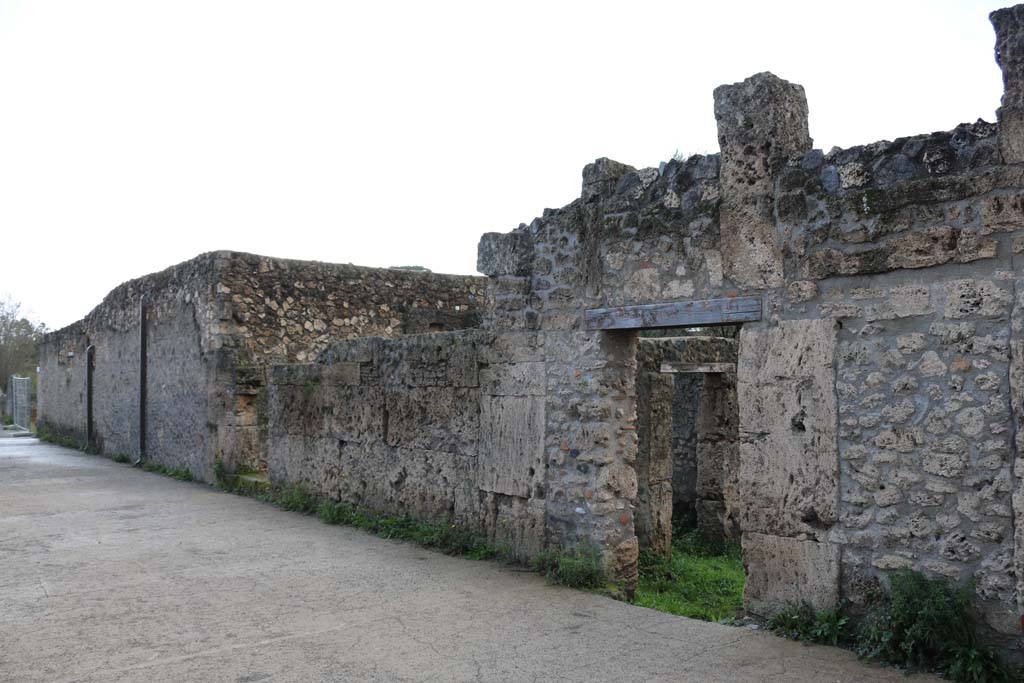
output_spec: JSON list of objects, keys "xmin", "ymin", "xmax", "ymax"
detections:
[{"xmin": 634, "ymin": 530, "xmax": 745, "ymax": 622}]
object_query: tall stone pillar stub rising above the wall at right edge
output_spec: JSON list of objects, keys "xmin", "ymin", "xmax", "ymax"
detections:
[{"xmin": 988, "ymin": 5, "xmax": 1024, "ymax": 164}]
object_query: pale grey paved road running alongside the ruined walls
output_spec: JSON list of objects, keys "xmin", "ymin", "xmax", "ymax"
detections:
[{"xmin": 0, "ymin": 438, "xmax": 935, "ymax": 683}]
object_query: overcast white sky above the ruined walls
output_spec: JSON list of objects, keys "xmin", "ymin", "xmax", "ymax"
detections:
[{"xmin": 0, "ymin": 0, "xmax": 1012, "ymax": 328}]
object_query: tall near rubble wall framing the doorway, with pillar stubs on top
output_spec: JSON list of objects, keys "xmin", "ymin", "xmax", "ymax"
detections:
[{"xmin": 479, "ymin": 2, "xmax": 1024, "ymax": 643}]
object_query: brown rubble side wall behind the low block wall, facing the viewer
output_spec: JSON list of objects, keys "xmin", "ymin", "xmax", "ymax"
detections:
[{"xmin": 208, "ymin": 254, "xmax": 485, "ymax": 470}]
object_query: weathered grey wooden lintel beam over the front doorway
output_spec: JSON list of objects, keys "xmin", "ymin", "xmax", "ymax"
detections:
[{"xmin": 584, "ymin": 296, "xmax": 761, "ymax": 330}]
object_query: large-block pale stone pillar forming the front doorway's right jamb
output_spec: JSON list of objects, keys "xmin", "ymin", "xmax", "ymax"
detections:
[{"xmin": 736, "ymin": 319, "xmax": 841, "ymax": 616}]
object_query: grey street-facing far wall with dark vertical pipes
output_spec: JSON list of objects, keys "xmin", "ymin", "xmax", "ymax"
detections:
[{"xmin": 39, "ymin": 254, "xmax": 217, "ymax": 476}]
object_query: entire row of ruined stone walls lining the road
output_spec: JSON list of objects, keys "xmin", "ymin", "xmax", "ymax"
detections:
[{"xmin": 40, "ymin": 5, "xmax": 1024, "ymax": 652}]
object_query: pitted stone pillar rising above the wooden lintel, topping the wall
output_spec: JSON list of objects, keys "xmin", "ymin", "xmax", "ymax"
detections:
[{"xmin": 715, "ymin": 72, "xmax": 811, "ymax": 289}]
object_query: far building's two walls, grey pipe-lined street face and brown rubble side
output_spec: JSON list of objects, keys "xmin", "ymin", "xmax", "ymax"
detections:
[{"xmin": 40, "ymin": 252, "xmax": 484, "ymax": 479}]
